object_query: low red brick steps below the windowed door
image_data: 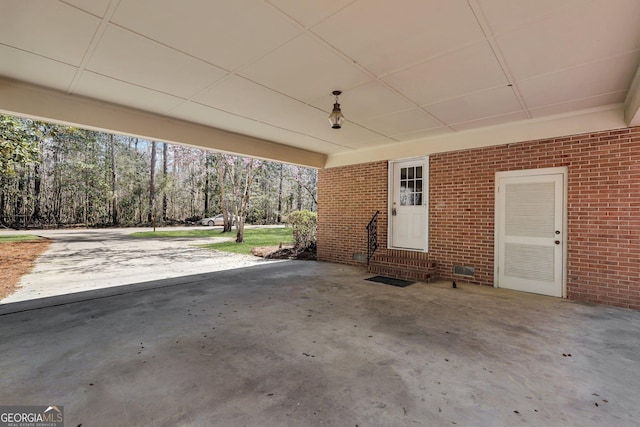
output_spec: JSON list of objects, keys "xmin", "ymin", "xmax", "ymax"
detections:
[{"xmin": 367, "ymin": 251, "xmax": 436, "ymax": 283}]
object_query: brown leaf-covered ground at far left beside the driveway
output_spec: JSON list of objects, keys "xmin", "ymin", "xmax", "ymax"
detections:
[{"xmin": 0, "ymin": 239, "xmax": 51, "ymax": 300}]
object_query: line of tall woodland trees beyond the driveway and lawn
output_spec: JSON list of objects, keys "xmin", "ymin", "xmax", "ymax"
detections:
[{"xmin": 0, "ymin": 115, "xmax": 317, "ymax": 238}]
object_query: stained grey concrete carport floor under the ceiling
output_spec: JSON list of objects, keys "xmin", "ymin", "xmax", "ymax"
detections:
[{"xmin": 0, "ymin": 261, "xmax": 640, "ymax": 427}]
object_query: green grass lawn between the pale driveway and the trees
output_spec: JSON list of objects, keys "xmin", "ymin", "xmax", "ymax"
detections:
[{"xmin": 131, "ymin": 227, "xmax": 293, "ymax": 254}]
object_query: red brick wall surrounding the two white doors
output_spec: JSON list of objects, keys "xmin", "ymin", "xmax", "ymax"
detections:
[{"xmin": 318, "ymin": 128, "xmax": 640, "ymax": 309}]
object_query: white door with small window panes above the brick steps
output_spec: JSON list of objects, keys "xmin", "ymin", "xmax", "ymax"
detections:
[{"xmin": 389, "ymin": 159, "xmax": 429, "ymax": 251}]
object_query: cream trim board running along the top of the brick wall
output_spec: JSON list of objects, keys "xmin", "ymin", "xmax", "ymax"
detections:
[{"xmin": 325, "ymin": 104, "xmax": 627, "ymax": 168}]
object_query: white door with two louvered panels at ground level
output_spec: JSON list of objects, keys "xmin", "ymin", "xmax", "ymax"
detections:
[{"xmin": 496, "ymin": 168, "xmax": 566, "ymax": 297}]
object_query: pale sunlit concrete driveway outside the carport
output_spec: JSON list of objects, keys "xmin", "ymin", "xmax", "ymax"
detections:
[{"xmin": 0, "ymin": 227, "xmax": 273, "ymax": 303}]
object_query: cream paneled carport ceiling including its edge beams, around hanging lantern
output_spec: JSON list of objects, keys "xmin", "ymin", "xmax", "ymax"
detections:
[{"xmin": 0, "ymin": 0, "xmax": 640, "ymax": 167}]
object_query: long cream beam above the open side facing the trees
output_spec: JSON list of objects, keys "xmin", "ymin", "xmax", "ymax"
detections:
[{"xmin": 0, "ymin": 77, "xmax": 327, "ymax": 168}]
